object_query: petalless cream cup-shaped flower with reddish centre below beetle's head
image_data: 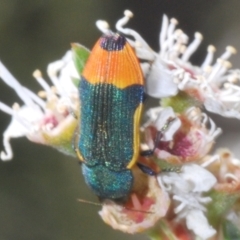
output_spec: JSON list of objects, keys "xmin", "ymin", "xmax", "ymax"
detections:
[{"xmin": 99, "ymin": 175, "xmax": 170, "ymax": 234}]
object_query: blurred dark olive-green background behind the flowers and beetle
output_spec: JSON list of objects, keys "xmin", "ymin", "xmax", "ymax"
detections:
[{"xmin": 0, "ymin": 0, "xmax": 240, "ymax": 240}]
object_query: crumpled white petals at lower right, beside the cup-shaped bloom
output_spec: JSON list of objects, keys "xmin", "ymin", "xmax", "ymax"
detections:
[{"xmin": 158, "ymin": 164, "xmax": 217, "ymax": 239}]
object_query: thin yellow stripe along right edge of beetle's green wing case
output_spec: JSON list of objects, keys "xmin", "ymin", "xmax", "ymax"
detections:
[{"xmin": 127, "ymin": 103, "xmax": 143, "ymax": 169}]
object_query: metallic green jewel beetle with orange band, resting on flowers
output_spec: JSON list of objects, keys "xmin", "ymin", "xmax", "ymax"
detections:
[{"xmin": 76, "ymin": 32, "xmax": 144, "ymax": 200}]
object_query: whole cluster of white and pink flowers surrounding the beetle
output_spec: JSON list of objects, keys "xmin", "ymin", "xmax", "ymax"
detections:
[{"xmin": 0, "ymin": 10, "xmax": 240, "ymax": 239}]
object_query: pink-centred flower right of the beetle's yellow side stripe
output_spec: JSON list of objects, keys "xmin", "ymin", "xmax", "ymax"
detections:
[{"xmin": 141, "ymin": 107, "xmax": 222, "ymax": 163}]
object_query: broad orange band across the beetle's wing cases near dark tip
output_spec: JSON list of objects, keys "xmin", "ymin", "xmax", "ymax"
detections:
[{"xmin": 82, "ymin": 41, "xmax": 143, "ymax": 89}]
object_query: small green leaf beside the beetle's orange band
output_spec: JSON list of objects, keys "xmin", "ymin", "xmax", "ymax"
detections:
[{"xmin": 72, "ymin": 43, "xmax": 90, "ymax": 75}]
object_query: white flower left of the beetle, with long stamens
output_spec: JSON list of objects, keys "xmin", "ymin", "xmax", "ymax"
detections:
[{"xmin": 0, "ymin": 51, "xmax": 79, "ymax": 160}]
